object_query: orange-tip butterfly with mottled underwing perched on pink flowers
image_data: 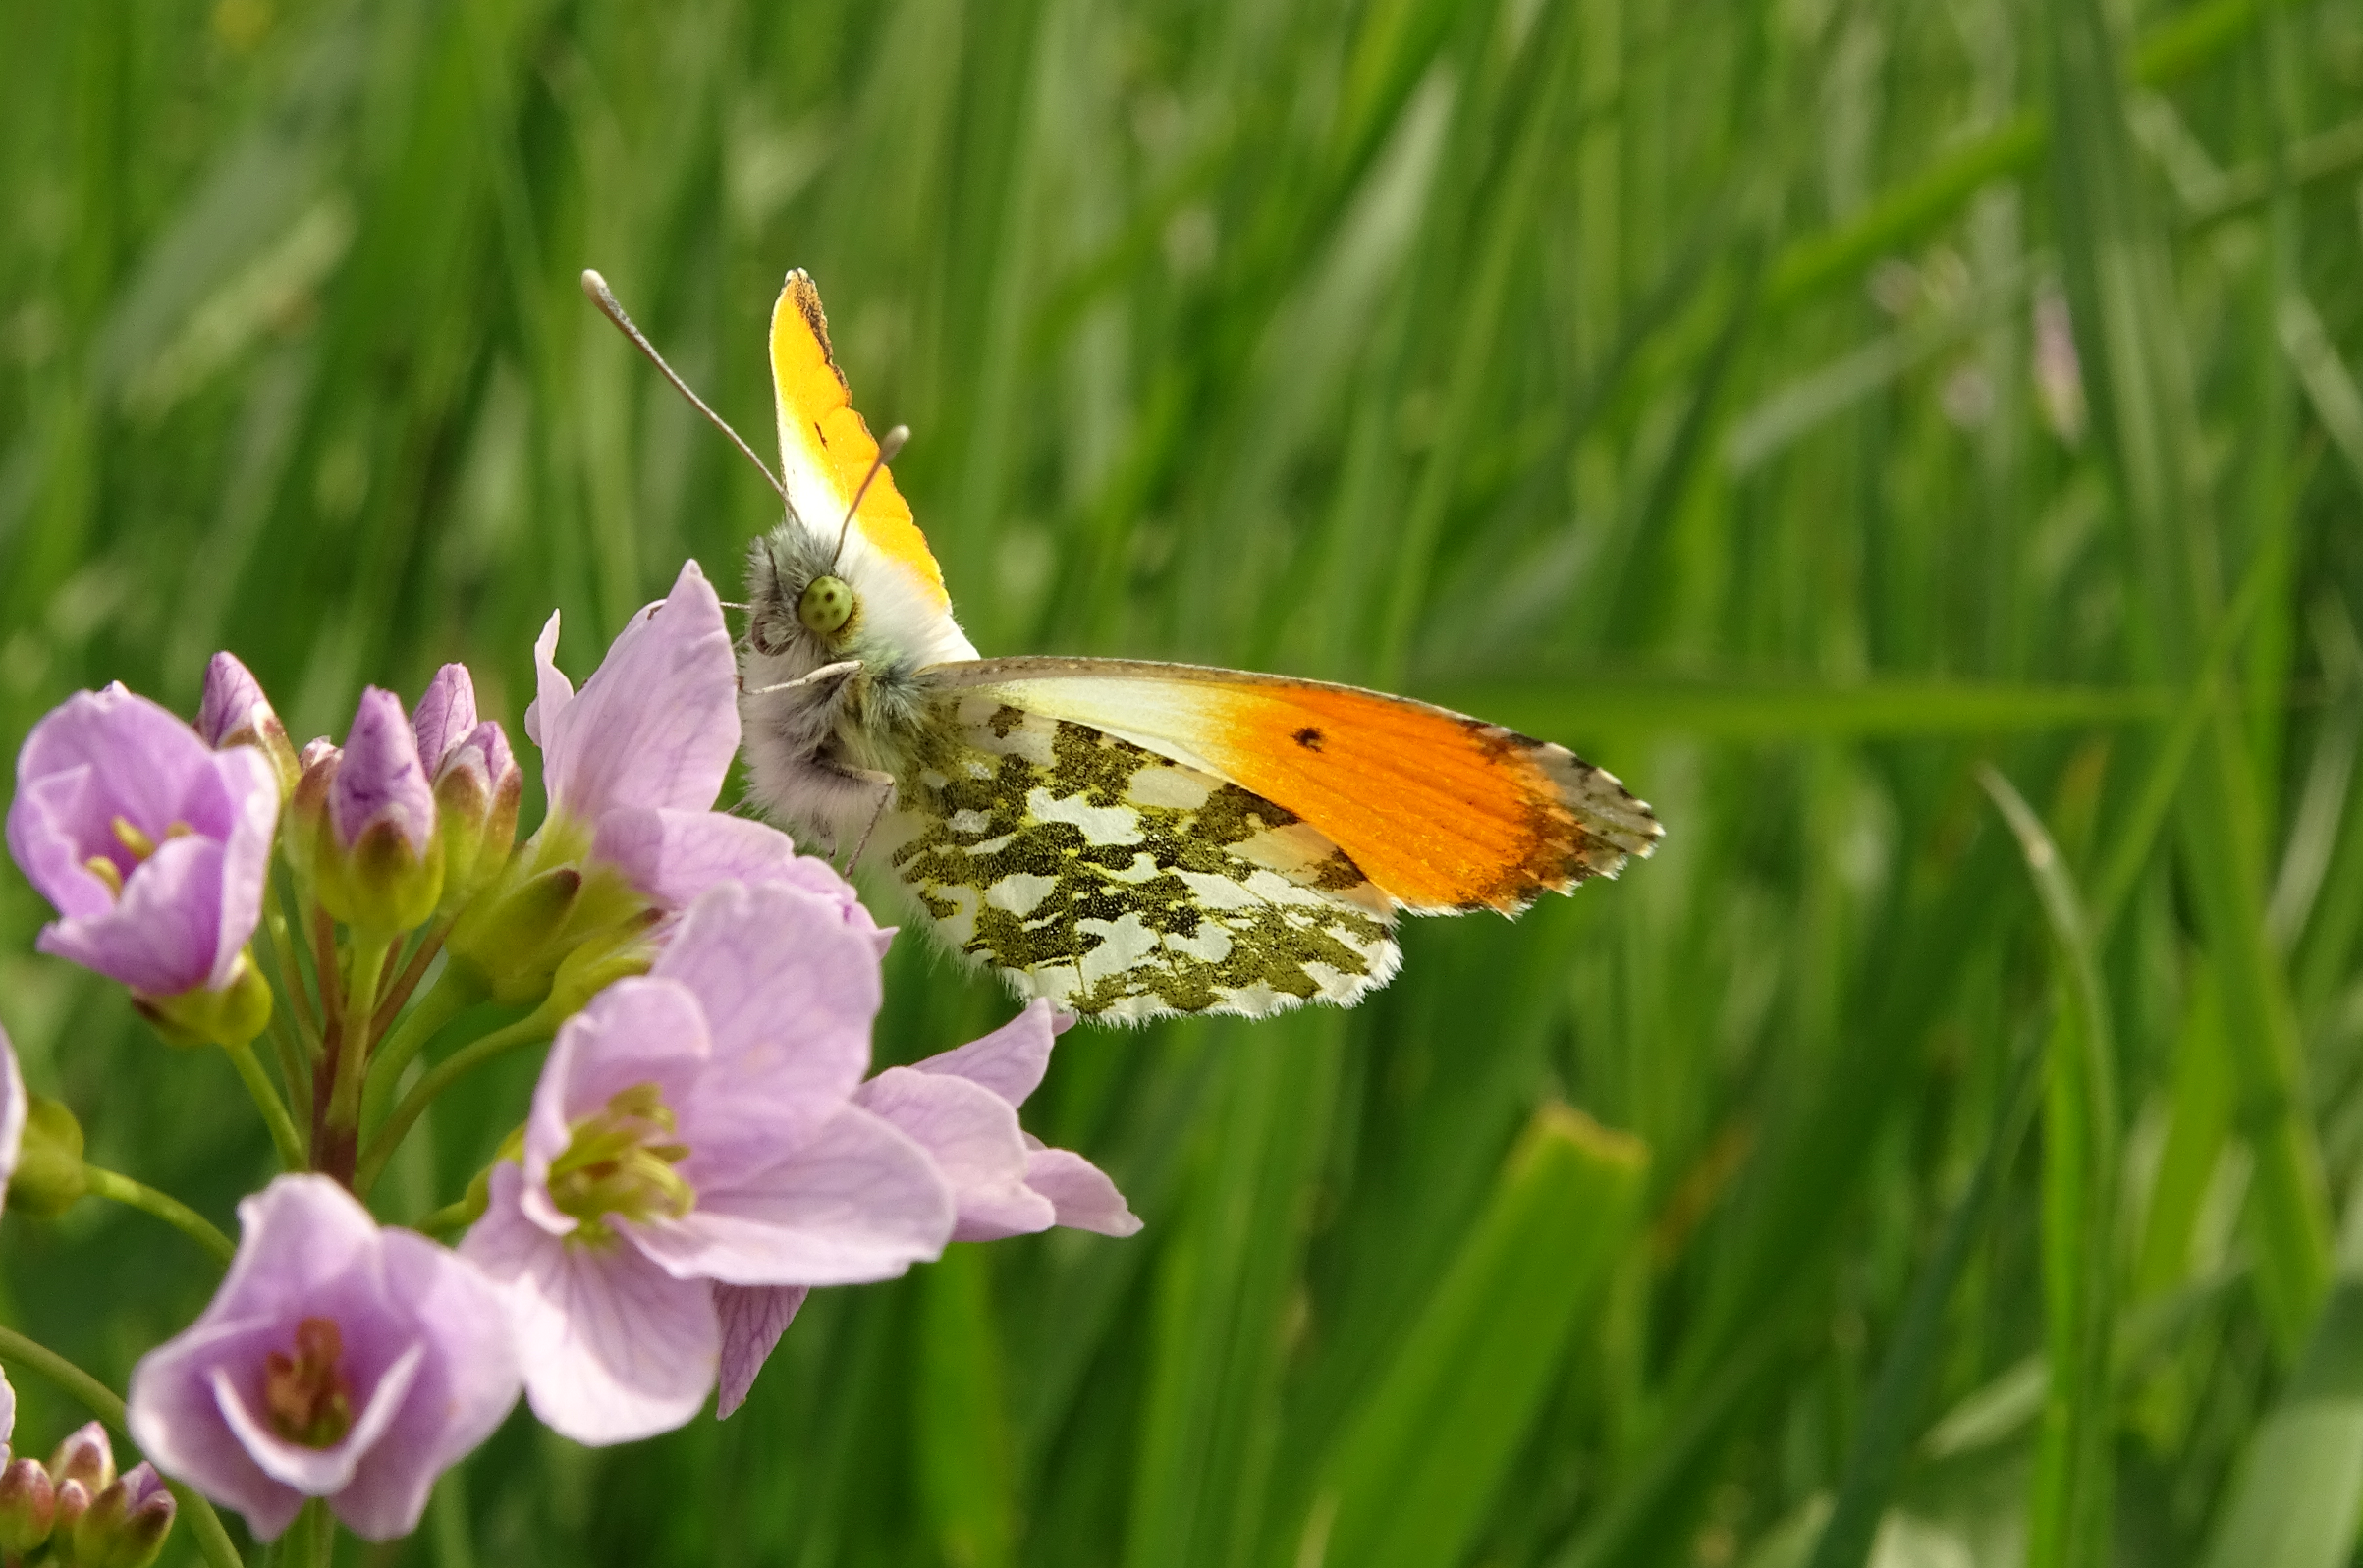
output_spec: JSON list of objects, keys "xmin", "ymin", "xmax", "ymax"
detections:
[{"xmin": 583, "ymin": 272, "xmax": 1664, "ymax": 1020}]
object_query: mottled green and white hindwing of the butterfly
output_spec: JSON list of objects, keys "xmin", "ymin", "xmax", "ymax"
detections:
[{"xmin": 877, "ymin": 689, "xmax": 1401, "ymax": 1020}]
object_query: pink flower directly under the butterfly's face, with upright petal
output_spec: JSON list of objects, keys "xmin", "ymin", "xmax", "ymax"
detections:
[{"xmin": 524, "ymin": 560, "xmax": 794, "ymax": 909}]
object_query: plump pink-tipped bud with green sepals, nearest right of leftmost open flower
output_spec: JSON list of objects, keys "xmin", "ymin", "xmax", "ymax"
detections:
[{"xmin": 311, "ymin": 687, "xmax": 444, "ymax": 935}]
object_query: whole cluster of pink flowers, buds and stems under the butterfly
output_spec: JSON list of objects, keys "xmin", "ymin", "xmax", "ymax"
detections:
[{"xmin": 0, "ymin": 562, "xmax": 1139, "ymax": 1568}]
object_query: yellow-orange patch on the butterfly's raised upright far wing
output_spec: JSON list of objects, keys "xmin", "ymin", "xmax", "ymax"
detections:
[{"xmin": 770, "ymin": 267, "xmax": 953, "ymax": 607}]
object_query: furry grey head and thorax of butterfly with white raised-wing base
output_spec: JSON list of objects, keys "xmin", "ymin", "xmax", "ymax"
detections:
[{"xmin": 740, "ymin": 513, "xmax": 976, "ymax": 850}]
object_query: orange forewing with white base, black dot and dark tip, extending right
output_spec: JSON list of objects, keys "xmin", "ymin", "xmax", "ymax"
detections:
[{"xmin": 988, "ymin": 661, "xmax": 1661, "ymax": 914}]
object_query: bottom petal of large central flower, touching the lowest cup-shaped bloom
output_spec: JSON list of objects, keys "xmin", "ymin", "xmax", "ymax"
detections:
[{"xmin": 461, "ymin": 1164, "xmax": 721, "ymax": 1445}]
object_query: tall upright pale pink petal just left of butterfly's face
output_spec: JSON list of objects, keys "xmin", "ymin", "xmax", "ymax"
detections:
[{"xmin": 539, "ymin": 560, "xmax": 740, "ymax": 822}]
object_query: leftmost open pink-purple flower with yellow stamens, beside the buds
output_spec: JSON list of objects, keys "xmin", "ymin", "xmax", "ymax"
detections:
[{"xmin": 7, "ymin": 684, "xmax": 279, "ymax": 997}]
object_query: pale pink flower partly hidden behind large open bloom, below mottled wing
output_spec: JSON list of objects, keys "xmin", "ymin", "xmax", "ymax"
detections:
[{"xmin": 714, "ymin": 999, "xmax": 1141, "ymax": 1415}]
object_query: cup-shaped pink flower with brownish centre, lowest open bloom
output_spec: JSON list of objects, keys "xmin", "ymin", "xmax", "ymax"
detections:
[{"xmin": 130, "ymin": 1176, "xmax": 518, "ymax": 1540}]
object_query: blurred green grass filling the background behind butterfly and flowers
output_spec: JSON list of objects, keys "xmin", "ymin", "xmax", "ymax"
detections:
[{"xmin": 0, "ymin": 0, "xmax": 2363, "ymax": 1568}]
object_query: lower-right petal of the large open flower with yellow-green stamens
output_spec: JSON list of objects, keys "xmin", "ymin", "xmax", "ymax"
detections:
[{"xmin": 637, "ymin": 1106, "xmax": 953, "ymax": 1284}]
